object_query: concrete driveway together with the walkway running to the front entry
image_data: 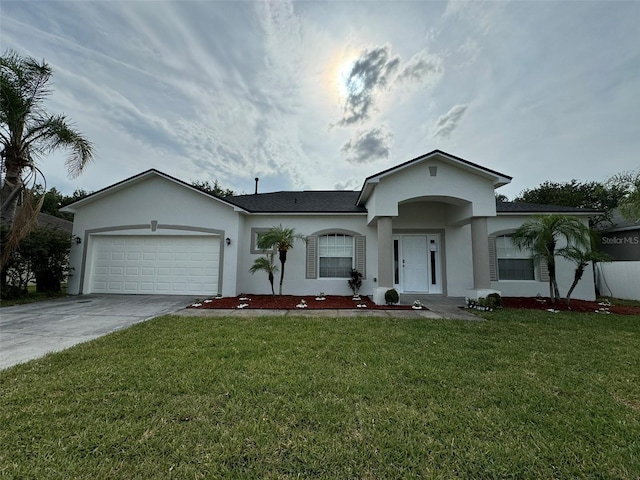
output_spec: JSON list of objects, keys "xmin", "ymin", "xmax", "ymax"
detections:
[{"xmin": 0, "ymin": 294, "xmax": 482, "ymax": 369}]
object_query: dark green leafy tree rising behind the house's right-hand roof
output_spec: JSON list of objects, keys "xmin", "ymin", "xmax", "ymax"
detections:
[{"xmin": 513, "ymin": 179, "xmax": 626, "ymax": 227}]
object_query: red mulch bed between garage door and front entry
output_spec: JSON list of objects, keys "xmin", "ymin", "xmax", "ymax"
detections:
[{"xmin": 189, "ymin": 295, "xmax": 411, "ymax": 310}]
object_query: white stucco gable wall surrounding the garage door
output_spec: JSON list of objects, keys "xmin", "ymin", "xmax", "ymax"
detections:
[{"xmin": 68, "ymin": 175, "xmax": 239, "ymax": 295}]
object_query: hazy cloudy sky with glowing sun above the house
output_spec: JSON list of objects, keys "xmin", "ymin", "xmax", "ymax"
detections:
[{"xmin": 0, "ymin": 0, "xmax": 640, "ymax": 198}]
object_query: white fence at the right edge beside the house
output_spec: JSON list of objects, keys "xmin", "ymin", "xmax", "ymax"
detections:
[{"xmin": 596, "ymin": 261, "xmax": 640, "ymax": 300}]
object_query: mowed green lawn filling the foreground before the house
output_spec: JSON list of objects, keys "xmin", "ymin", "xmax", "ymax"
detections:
[{"xmin": 0, "ymin": 310, "xmax": 640, "ymax": 479}]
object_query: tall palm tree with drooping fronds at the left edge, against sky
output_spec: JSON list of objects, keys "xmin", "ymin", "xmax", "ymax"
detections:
[{"xmin": 0, "ymin": 50, "xmax": 93, "ymax": 266}]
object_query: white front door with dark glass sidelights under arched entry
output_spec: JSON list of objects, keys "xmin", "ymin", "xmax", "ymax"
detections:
[{"xmin": 394, "ymin": 234, "xmax": 442, "ymax": 293}]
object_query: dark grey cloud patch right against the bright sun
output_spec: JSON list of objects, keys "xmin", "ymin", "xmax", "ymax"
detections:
[{"xmin": 338, "ymin": 45, "xmax": 400, "ymax": 126}]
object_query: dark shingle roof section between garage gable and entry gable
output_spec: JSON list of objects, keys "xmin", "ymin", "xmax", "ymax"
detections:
[{"xmin": 225, "ymin": 190, "xmax": 367, "ymax": 213}]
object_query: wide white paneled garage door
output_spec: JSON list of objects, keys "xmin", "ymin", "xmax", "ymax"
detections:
[{"xmin": 90, "ymin": 235, "xmax": 220, "ymax": 295}]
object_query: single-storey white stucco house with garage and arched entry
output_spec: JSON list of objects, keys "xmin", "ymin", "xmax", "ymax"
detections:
[{"xmin": 64, "ymin": 150, "xmax": 595, "ymax": 303}]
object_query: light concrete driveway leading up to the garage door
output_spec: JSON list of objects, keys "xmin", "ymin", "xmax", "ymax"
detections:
[{"xmin": 0, "ymin": 294, "xmax": 194, "ymax": 369}]
